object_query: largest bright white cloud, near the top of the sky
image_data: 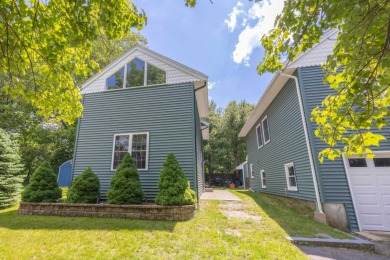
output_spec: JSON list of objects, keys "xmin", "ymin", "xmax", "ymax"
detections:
[{"xmin": 232, "ymin": 0, "xmax": 284, "ymax": 66}]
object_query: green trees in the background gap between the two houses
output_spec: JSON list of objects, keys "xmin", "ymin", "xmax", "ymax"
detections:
[{"xmin": 204, "ymin": 101, "xmax": 253, "ymax": 173}]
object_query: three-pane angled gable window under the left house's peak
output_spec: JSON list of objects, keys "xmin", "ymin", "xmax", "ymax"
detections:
[{"xmin": 106, "ymin": 58, "xmax": 166, "ymax": 89}]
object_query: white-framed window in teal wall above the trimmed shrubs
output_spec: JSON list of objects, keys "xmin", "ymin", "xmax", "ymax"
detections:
[{"xmin": 111, "ymin": 133, "xmax": 149, "ymax": 170}]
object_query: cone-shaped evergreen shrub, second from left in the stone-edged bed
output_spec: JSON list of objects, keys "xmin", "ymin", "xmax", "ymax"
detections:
[{"xmin": 67, "ymin": 167, "xmax": 100, "ymax": 203}]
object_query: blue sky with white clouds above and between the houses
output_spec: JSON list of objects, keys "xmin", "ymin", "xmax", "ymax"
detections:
[{"xmin": 133, "ymin": 0, "xmax": 283, "ymax": 108}]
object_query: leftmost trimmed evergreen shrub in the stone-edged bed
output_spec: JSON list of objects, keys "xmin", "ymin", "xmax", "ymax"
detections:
[{"xmin": 22, "ymin": 162, "xmax": 62, "ymax": 202}]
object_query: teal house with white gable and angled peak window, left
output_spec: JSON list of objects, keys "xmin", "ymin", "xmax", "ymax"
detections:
[{"xmin": 73, "ymin": 46, "xmax": 208, "ymax": 200}]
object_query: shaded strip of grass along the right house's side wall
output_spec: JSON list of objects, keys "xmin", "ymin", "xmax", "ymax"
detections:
[{"xmin": 237, "ymin": 191, "xmax": 350, "ymax": 238}]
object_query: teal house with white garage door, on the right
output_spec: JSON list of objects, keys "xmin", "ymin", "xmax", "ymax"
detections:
[{"xmin": 240, "ymin": 31, "xmax": 390, "ymax": 231}]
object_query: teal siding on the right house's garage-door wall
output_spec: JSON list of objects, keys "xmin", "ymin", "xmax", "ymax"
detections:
[{"xmin": 298, "ymin": 66, "xmax": 390, "ymax": 230}]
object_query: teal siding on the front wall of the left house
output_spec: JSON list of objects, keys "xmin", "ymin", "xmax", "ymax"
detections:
[{"xmin": 73, "ymin": 83, "xmax": 196, "ymax": 200}]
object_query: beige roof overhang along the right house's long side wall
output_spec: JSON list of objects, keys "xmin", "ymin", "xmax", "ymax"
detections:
[{"xmin": 238, "ymin": 68, "xmax": 296, "ymax": 137}]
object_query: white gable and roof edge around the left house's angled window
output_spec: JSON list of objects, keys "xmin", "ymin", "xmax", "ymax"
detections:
[{"xmin": 80, "ymin": 45, "xmax": 208, "ymax": 117}]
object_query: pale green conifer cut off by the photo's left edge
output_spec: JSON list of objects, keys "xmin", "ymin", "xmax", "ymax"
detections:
[{"xmin": 0, "ymin": 128, "xmax": 23, "ymax": 208}]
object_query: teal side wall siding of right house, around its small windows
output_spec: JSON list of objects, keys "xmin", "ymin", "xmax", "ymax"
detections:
[{"xmin": 246, "ymin": 80, "xmax": 315, "ymax": 200}]
